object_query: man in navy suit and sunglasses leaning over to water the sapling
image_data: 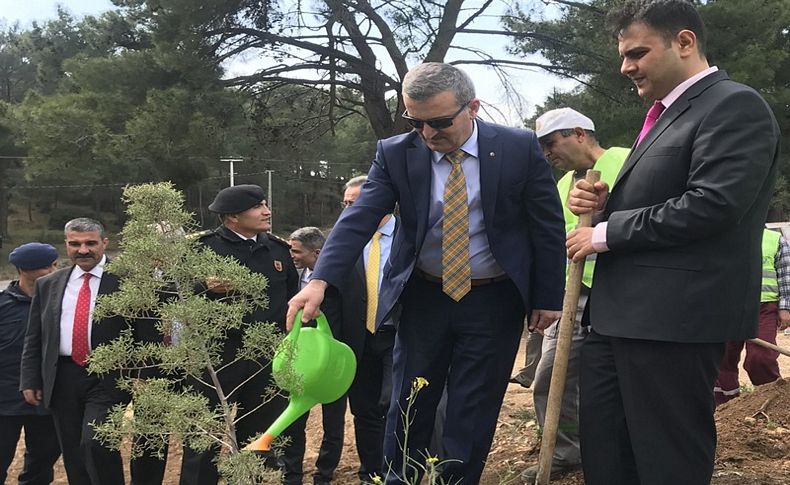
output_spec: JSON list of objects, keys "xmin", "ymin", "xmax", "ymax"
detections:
[{"xmin": 286, "ymin": 63, "xmax": 565, "ymax": 483}]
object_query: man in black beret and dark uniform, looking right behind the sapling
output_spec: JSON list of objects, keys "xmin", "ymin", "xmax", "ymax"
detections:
[{"xmin": 181, "ymin": 185, "xmax": 301, "ymax": 485}]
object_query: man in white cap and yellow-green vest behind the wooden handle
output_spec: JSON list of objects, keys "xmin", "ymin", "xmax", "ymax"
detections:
[{"xmin": 522, "ymin": 108, "xmax": 629, "ymax": 483}]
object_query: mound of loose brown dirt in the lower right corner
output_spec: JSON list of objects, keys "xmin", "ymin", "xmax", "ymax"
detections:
[{"xmin": 713, "ymin": 379, "xmax": 790, "ymax": 484}]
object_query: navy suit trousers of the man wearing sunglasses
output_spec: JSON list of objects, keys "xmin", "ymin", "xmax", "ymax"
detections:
[{"xmin": 383, "ymin": 275, "xmax": 525, "ymax": 484}]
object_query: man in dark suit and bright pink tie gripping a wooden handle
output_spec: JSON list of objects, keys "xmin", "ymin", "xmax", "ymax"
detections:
[{"xmin": 567, "ymin": 0, "xmax": 779, "ymax": 485}]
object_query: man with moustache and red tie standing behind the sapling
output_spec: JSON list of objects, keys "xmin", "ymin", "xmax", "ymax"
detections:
[{"xmin": 20, "ymin": 218, "xmax": 136, "ymax": 485}]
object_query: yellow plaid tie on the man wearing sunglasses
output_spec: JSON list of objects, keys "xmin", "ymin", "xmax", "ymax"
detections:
[{"xmin": 442, "ymin": 150, "xmax": 472, "ymax": 301}]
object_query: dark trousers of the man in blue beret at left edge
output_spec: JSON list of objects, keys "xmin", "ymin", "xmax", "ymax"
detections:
[{"xmin": 0, "ymin": 414, "xmax": 60, "ymax": 485}]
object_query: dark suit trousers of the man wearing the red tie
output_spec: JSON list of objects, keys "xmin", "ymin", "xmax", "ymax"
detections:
[{"xmin": 50, "ymin": 357, "xmax": 124, "ymax": 485}]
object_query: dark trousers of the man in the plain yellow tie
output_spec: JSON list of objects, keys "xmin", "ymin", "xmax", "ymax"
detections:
[{"xmin": 348, "ymin": 326, "xmax": 395, "ymax": 481}]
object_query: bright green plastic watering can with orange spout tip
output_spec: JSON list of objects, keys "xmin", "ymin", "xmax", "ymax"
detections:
[{"xmin": 246, "ymin": 310, "xmax": 357, "ymax": 451}]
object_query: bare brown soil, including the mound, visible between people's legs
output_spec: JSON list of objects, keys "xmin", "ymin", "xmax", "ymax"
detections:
[{"xmin": 8, "ymin": 334, "xmax": 790, "ymax": 485}]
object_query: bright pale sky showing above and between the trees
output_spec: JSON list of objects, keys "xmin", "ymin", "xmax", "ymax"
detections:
[{"xmin": 0, "ymin": 0, "xmax": 574, "ymax": 126}]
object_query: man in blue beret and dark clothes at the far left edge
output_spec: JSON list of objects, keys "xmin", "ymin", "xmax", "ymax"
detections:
[{"xmin": 0, "ymin": 242, "xmax": 60, "ymax": 484}]
